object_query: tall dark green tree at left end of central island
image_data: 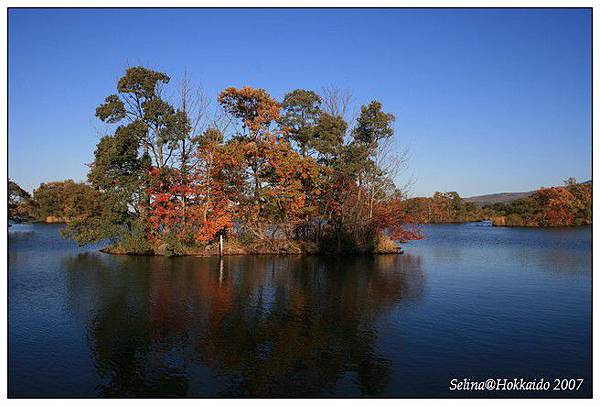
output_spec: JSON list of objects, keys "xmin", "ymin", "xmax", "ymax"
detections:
[{"xmin": 66, "ymin": 66, "xmax": 205, "ymax": 250}]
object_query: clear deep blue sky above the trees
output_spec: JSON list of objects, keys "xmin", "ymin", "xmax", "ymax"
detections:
[{"xmin": 8, "ymin": 9, "xmax": 592, "ymax": 196}]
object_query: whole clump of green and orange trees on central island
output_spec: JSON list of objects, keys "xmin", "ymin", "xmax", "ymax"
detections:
[{"xmin": 59, "ymin": 66, "xmax": 426, "ymax": 254}]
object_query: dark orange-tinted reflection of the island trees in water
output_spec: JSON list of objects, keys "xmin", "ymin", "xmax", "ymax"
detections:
[{"xmin": 65, "ymin": 253, "xmax": 425, "ymax": 396}]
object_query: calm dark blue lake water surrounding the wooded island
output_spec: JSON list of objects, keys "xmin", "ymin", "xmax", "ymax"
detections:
[{"xmin": 8, "ymin": 224, "xmax": 592, "ymax": 397}]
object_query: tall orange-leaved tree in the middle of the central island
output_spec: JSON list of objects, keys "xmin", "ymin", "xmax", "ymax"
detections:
[{"xmin": 219, "ymin": 87, "xmax": 318, "ymax": 238}]
